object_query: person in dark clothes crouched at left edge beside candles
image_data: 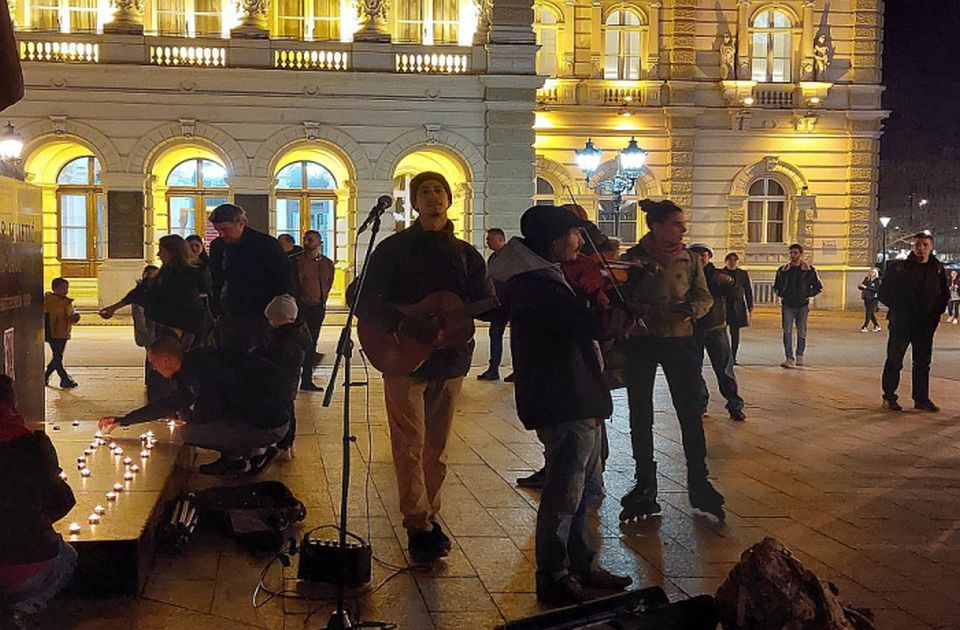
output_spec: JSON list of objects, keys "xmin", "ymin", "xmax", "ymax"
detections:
[{"xmin": 0, "ymin": 374, "xmax": 77, "ymax": 625}]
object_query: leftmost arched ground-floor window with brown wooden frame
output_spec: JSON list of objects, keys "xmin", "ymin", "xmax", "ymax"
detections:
[{"xmin": 57, "ymin": 155, "xmax": 106, "ymax": 278}]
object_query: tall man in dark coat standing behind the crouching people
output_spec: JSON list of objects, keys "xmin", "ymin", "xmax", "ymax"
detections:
[{"xmin": 210, "ymin": 203, "xmax": 293, "ymax": 350}]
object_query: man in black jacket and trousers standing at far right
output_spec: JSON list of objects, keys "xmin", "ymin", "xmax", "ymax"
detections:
[{"xmin": 880, "ymin": 232, "xmax": 950, "ymax": 412}]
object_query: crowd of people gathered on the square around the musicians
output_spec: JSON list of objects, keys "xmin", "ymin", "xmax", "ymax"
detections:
[{"xmin": 7, "ymin": 172, "xmax": 960, "ymax": 620}]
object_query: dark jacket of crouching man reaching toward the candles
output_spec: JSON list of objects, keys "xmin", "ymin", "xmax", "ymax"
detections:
[{"xmin": 117, "ymin": 348, "xmax": 290, "ymax": 429}]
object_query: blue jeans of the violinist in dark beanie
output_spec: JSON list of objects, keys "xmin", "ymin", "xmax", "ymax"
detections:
[{"xmin": 536, "ymin": 419, "xmax": 603, "ymax": 582}]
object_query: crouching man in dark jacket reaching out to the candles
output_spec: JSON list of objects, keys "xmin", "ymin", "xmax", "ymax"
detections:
[{"xmin": 100, "ymin": 337, "xmax": 290, "ymax": 475}]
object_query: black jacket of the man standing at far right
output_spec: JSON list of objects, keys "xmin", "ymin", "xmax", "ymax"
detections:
[{"xmin": 879, "ymin": 253, "xmax": 950, "ymax": 330}]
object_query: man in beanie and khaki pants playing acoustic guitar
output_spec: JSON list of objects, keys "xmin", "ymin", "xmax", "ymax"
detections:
[{"xmin": 348, "ymin": 172, "xmax": 493, "ymax": 562}]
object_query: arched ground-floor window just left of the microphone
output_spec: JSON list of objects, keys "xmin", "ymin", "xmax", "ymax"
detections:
[{"xmin": 276, "ymin": 160, "xmax": 337, "ymax": 260}]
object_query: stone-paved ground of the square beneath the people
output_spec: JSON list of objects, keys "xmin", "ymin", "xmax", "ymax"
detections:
[{"xmin": 31, "ymin": 312, "xmax": 960, "ymax": 630}]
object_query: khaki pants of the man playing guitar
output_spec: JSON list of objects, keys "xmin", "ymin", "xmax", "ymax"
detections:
[{"xmin": 383, "ymin": 376, "xmax": 463, "ymax": 531}]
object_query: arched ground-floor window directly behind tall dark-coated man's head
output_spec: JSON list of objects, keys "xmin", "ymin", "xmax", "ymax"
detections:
[{"xmin": 167, "ymin": 158, "xmax": 230, "ymax": 239}]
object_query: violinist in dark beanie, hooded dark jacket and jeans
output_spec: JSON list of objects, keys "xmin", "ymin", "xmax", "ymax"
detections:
[{"xmin": 490, "ymin": 206, "xmax": 632, "ymax": 605}]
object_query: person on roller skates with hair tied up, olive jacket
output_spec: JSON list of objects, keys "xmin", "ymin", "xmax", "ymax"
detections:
[{"xmin": 620, "ymin": 199, "xmax": 724, "ymax": 520}]
